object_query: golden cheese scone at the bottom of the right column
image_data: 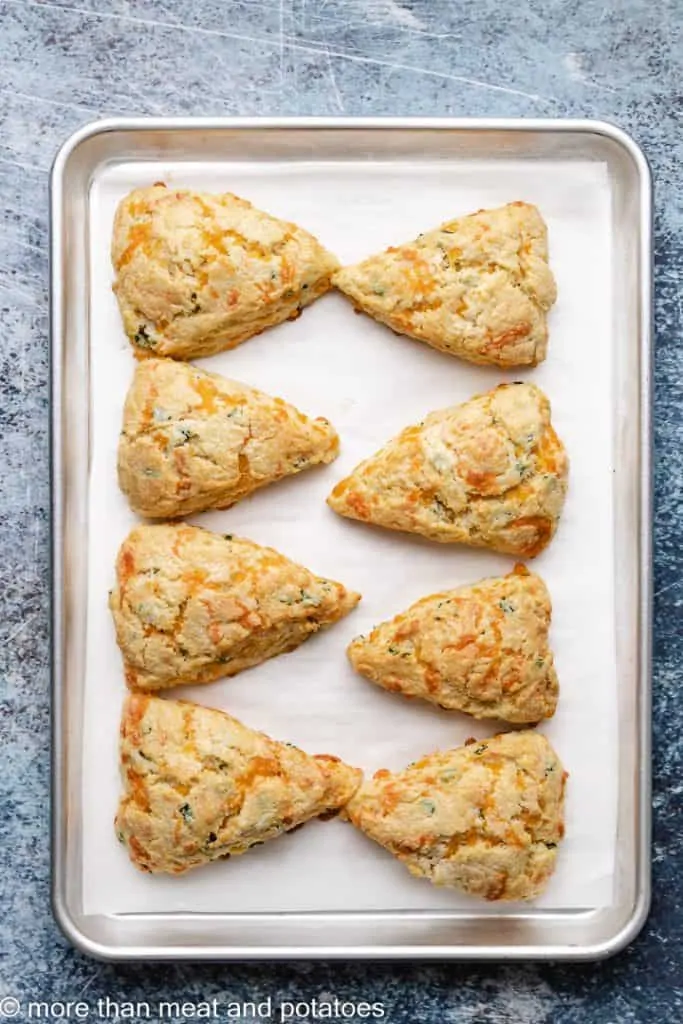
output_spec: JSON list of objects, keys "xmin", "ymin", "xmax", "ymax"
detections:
[{"xmin": 343, "ymin": 730, "xmax": 566, "ymax": 900}]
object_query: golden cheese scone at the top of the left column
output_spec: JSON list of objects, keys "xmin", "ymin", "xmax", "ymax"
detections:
[{"xmin": 112, "ymin": 182, "xmax": 339, "ymax": 359}]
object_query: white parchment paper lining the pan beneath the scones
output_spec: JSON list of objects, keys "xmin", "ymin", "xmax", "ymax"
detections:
[{"xmin": 83, "ymin": 161, "xmax": 617, "ymax": 914}]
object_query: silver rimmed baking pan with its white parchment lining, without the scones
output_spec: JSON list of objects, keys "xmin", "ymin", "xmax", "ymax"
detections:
[{"xmin": 51, "ymin": 119, "xmax": 651, "ymax": 959}]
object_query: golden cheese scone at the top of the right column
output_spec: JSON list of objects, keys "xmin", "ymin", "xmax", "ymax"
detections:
[{"xmin": 332, "ymin": 203, "xmax": 556, "ymax": 367}]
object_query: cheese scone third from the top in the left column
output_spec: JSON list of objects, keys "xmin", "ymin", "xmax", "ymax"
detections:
[{"xmin": 110, "ymin": 524, "xmax": 360, "ymax": 690}]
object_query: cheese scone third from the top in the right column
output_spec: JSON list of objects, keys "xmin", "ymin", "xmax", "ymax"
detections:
[{"xmin": 348, "ymin": 565, "xmax": 558, "ymax": 723}]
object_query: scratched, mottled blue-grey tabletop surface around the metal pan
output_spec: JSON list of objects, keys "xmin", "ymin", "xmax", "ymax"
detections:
[{"xmin": 0, "ymin": 0, "xmax": 683, "ymax": 1024}]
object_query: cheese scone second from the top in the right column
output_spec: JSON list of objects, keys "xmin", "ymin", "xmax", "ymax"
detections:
[{"xmin": 328, "ymin": 384, "xmax": 568, "ymax": 558}]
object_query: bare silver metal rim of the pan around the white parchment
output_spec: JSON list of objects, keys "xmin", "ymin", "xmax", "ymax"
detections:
[{"xmin": 51, "ymin": 119, "xmax": 651, "ymax": 959}]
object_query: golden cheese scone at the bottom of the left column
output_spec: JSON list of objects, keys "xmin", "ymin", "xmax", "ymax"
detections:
[{"xmin": 116, "ymin": 694, "xmax": 362, "ymax": 874}]
